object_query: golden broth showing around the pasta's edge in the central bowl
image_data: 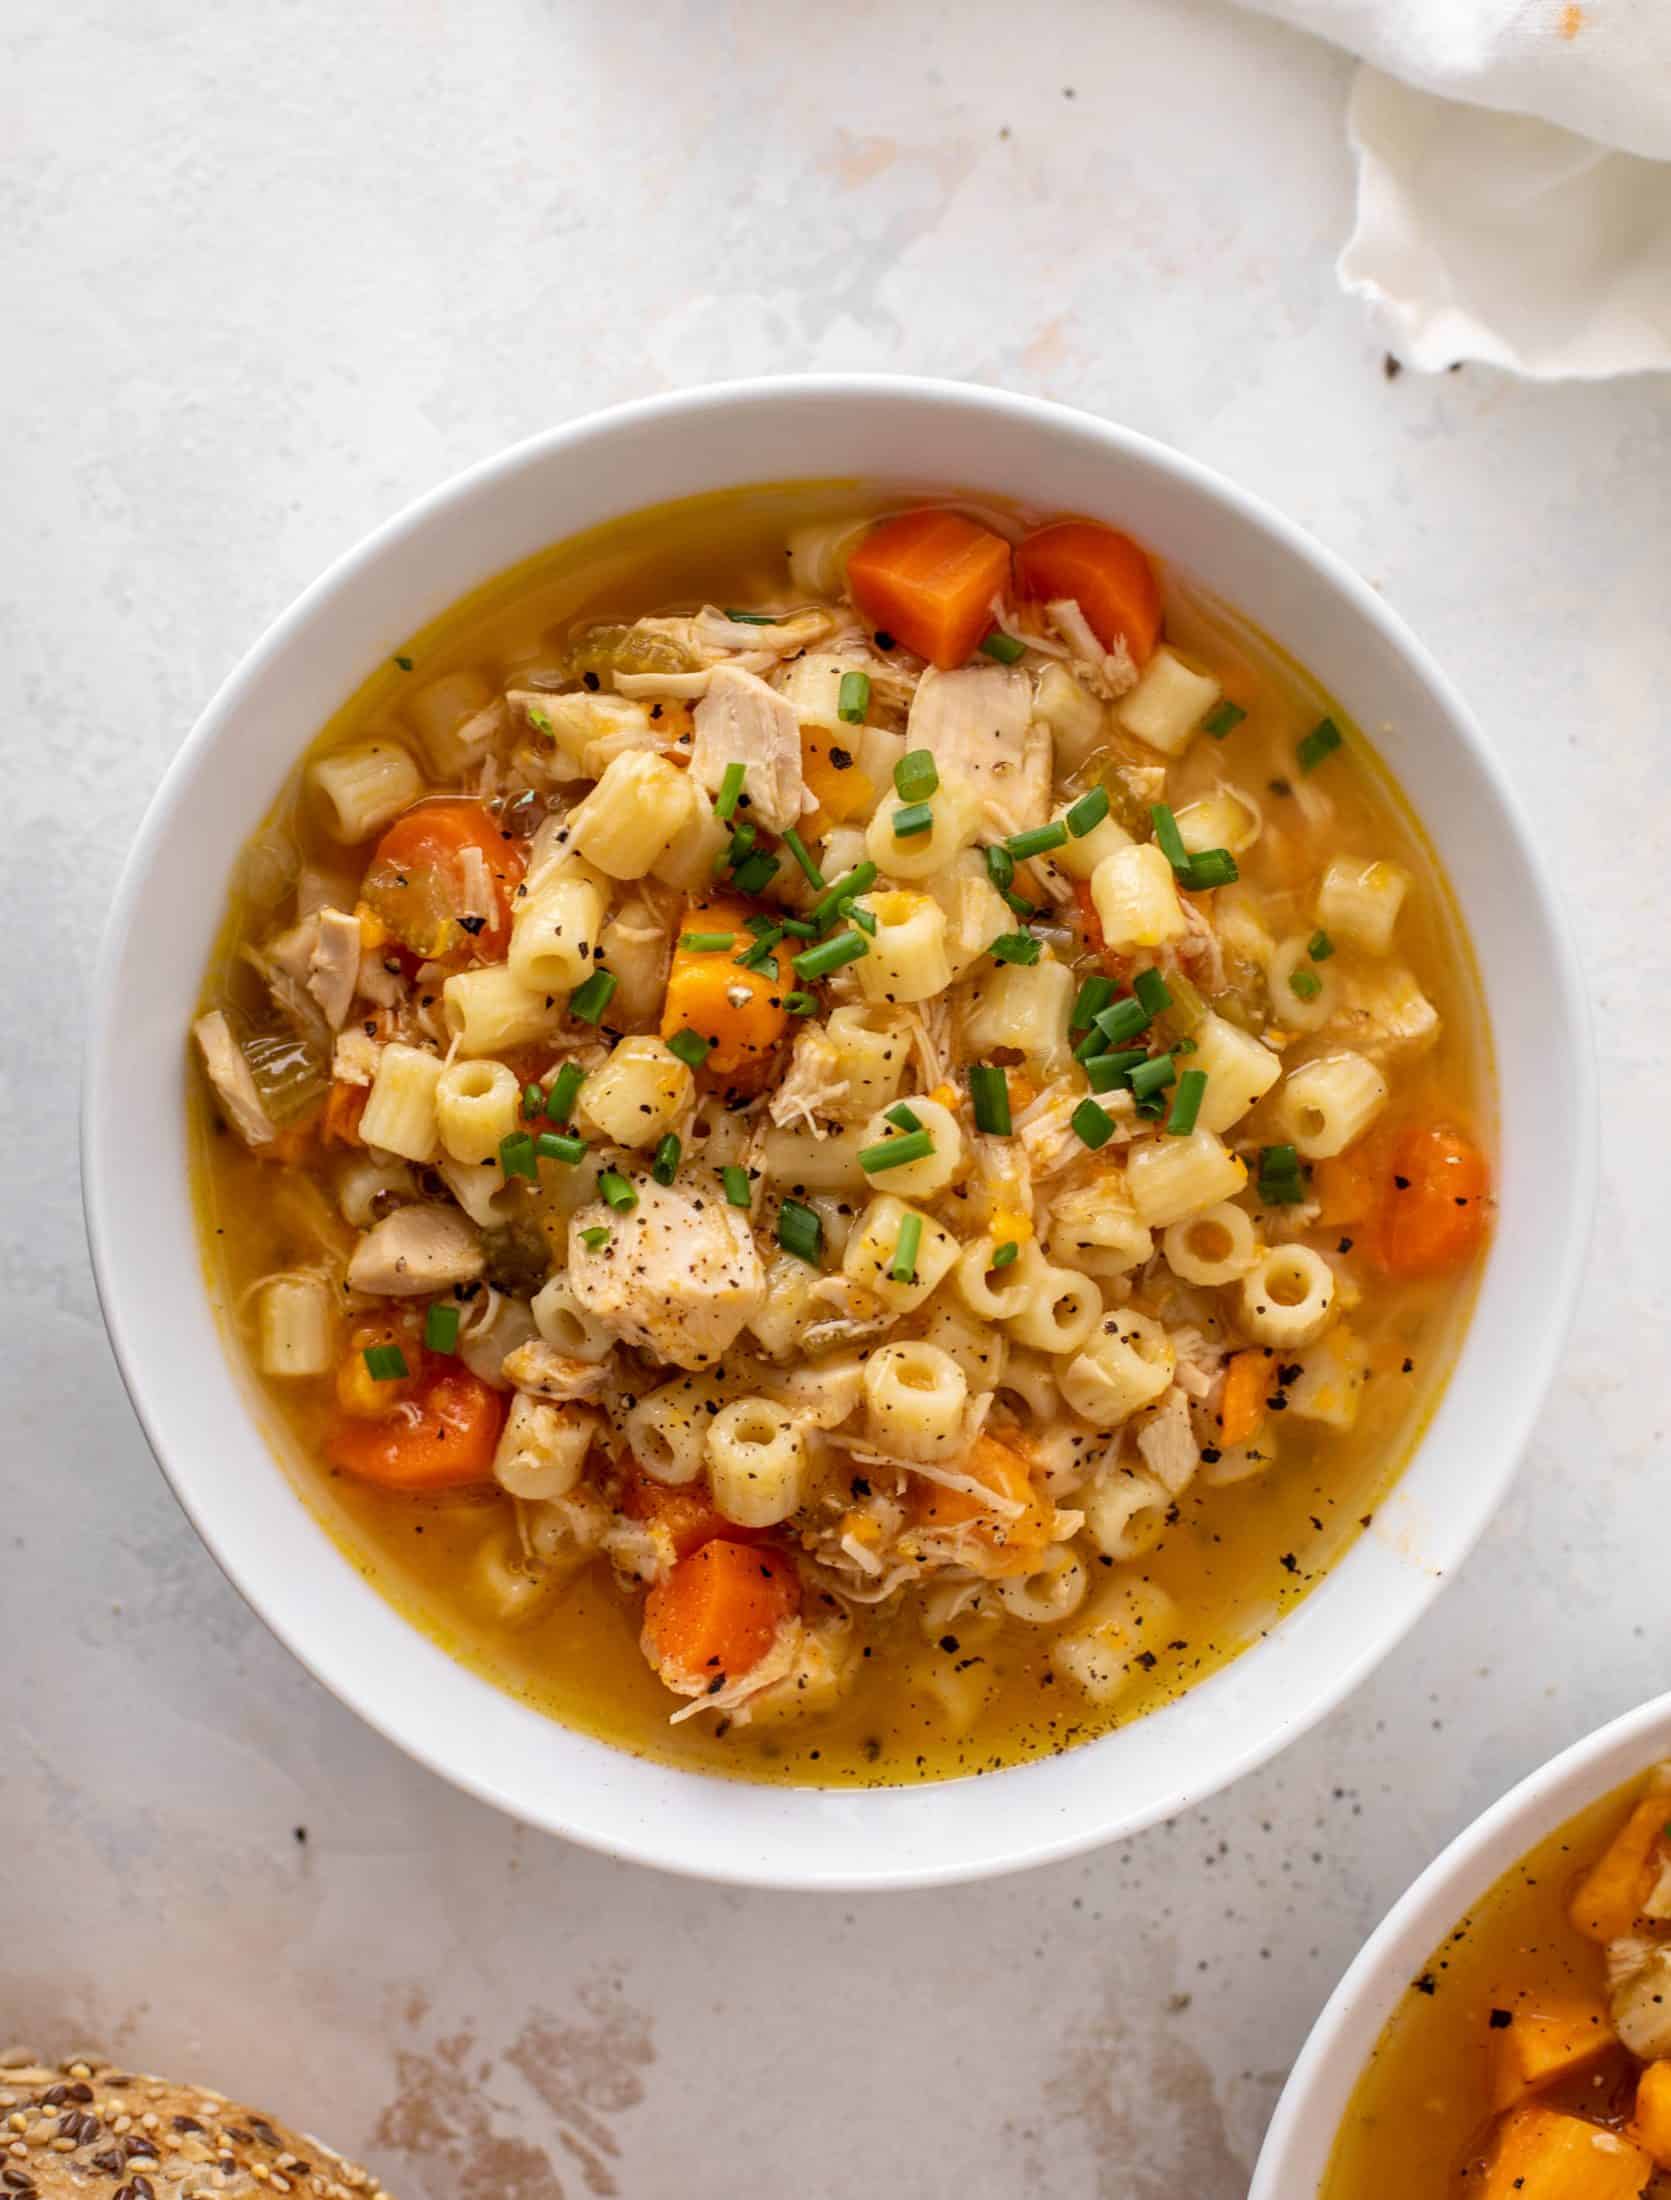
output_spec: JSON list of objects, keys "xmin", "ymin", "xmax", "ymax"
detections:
[{"xmin": 191, "ymin": 482, "xmax": 1495, "ymax": 1784}]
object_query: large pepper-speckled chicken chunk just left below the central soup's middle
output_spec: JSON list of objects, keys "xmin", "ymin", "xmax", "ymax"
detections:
[{"xmin": 569, "ymin": 1177, "xmax": 765, "ymax": 1368}]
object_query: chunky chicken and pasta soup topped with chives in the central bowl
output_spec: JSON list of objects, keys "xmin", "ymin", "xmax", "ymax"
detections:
[{"xmin": 193, "ymin": 484, "xmax": 1491, "ymax": 1782}]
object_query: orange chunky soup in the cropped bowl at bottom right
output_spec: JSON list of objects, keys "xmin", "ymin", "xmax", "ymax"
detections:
[{"xmin": 1321, "ymin": 1764, "xmax": 1671, "ymax": 2200}]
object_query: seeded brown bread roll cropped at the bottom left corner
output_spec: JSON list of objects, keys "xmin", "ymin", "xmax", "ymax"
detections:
[{"xmin": 0, "ymin": 2050, "xmax": 391, "ymax": 2200}]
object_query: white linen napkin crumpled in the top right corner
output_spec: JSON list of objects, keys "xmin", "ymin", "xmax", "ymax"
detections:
[{"xmin": 1244, "ymin": 0, "xmax": 1671, "ymax": 381}]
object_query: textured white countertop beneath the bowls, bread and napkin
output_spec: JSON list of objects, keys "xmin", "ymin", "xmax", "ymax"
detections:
[{"xmin": 0, "ymin": 0, "xmax": 1671, "ymax": 2200}]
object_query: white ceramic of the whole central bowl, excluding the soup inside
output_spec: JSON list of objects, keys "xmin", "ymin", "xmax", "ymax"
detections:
[{"xmin": 84, "ymin": 376, "xmax": 1594, "ymax": 1888}]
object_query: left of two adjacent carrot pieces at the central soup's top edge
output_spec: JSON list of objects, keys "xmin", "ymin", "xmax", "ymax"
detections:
[{"xmin": 846, "ymin": 510, "xmax": 1009, "ymax": 671}]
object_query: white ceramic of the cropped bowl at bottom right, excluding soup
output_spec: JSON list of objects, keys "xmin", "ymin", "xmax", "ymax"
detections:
[{"xmin": 1247, "ymin": 1696, "xmax": 1671, "ymax": 2200}]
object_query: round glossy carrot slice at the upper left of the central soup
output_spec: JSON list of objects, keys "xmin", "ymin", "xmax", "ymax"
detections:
[{"xmin": 361, "ymin": 796, "xmax": 525, "ymax": 961}]
